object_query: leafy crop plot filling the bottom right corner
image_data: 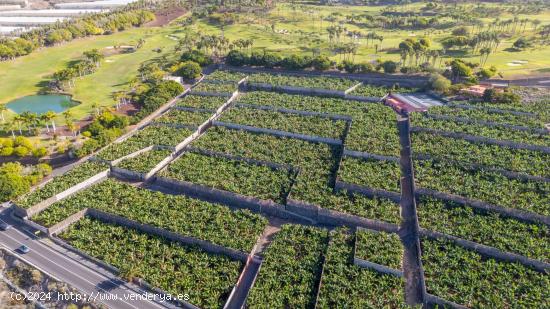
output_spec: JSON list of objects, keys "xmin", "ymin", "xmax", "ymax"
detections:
[{"xmin": 422, "ymin": 239, "xmax": 550, "ymax": 308}]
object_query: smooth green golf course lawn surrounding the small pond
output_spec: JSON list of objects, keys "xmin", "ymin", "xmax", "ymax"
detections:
[{"xmin": 0, "ymin": 26, "xmax": 178, "ymax": 121}]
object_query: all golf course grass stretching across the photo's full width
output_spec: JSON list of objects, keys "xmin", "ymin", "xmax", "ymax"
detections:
[{"xmin": 0, "ymin": 4, "xmax": 550, "ymax": 121}]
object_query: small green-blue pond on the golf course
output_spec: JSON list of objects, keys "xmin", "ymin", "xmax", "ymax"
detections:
[{"xmin": 6, "ymin": 95, "xmax": 78, "ymax": 114}]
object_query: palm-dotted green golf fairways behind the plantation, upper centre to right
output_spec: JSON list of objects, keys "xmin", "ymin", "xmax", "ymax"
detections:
[{"xmin": 196, "ymin": 4, "xmax": 550, "ymax": 78}]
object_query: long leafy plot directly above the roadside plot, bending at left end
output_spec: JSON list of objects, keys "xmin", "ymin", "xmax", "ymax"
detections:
[{"xmin": 32, "ymin": 179, "xmax": 266, "ymax": 251}]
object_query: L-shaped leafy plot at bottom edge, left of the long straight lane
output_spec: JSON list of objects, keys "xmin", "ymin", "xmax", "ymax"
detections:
[{"xmin": 317, "ymin": 229, "xmax": 408, "ymax": 308}]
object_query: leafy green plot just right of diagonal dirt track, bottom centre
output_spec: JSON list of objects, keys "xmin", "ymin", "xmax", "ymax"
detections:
[{"xmin": 247, "ymin": 225, "xmax": 328, "ymax": 308}]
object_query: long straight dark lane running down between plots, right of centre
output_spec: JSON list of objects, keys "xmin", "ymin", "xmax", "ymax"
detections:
[{"xmin": 397, "ymin": 112, "xmax": 426, "ymax": 307}]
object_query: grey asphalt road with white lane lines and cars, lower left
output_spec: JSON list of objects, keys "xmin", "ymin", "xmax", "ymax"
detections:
[{"xmin": 0, "ymin": 208, "xmax": 180, "ymax": 309}]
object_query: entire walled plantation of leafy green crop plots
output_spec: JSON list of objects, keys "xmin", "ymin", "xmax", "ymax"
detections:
[{"xmin": 21, "ymin": 71, "xmax": 550, "ymax": 308}]
